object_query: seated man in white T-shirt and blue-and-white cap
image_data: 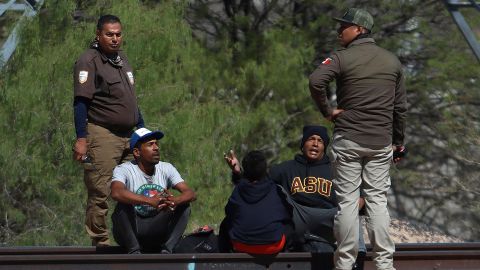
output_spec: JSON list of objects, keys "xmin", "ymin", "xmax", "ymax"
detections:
[{"xmin": 110, "ymin": 128, "xmax": 195, "ymax": 254}]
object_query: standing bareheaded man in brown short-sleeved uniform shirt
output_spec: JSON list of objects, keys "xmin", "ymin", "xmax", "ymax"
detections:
[{"xmin": 73, "ymin": 15, "xmax": 144, "ymax": 246}]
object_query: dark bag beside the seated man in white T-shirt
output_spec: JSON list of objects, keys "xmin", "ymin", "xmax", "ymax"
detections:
[{"xmin": 173, "ymin": 226, "xmax": 219, "ymax": 253}]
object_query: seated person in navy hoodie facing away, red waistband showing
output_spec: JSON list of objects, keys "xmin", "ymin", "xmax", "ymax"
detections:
[{"xmin": 220, "ymin": 151, "xmax": 291, "ymax": 254}]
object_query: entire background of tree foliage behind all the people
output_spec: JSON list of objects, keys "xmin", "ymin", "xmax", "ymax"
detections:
[{"xmin": 0, "ymin": 0, "xmax": 480, "ymax": 245}]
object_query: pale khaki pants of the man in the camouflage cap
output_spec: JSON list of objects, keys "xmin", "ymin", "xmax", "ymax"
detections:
[{"xmin": 330, "ymin": 135, "xmax": 395, "ymax": 270}]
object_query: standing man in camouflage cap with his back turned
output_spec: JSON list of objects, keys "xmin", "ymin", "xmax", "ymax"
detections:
[{"xmin": 310, "ymin": 8, "xmax": 407, "ymax": 270}]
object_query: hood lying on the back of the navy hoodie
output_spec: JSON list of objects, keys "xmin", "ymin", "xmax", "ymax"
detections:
[{"xmin": 237, "ymin": 178, "xmax": 275, "ymax": 204}]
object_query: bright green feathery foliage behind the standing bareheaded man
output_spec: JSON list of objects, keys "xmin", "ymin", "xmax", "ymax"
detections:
[{"xmin": 0, "ymin": 0, "xmax": 322, "ymax": 245}]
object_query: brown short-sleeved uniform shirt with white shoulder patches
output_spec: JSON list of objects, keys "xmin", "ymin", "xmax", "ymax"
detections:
[{"xmin": 73, "ymin": 49, "xmax": 139, "ymax": 132}]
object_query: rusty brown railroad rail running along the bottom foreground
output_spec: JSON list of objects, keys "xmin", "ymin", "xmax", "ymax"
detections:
[{"xmin": 0, "ymin": 243, "xmax": 480, "ymax": 270}]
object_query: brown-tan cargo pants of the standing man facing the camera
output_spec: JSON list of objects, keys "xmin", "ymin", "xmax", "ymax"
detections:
[{"xmin": 83, "ymin": 123, "xmax": 133, "ymax": 246}]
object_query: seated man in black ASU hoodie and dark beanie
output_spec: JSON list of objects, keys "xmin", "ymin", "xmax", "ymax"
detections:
[{"xmin": 225, "ymin": 125, "xmax": 366, "ymax": 269}]
